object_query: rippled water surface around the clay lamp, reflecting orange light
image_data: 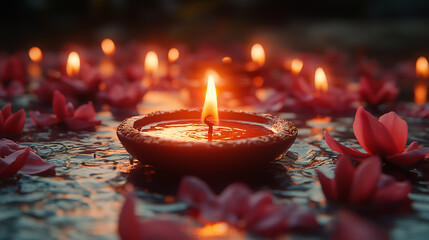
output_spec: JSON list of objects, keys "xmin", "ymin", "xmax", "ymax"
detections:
[{"xmin": 0, "ymin": 109, "xmax": 429, "ymax": 239}]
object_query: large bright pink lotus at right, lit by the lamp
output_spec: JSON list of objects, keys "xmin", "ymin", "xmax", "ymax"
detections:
[{"xmin": 325, "ymin": 107, "xmax": 429, "ymax": 165}]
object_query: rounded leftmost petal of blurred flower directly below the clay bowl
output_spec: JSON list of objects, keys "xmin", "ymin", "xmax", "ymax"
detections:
[{"xmin": 177, "ymin": 176, "xmax": 216, "ymax": 208}]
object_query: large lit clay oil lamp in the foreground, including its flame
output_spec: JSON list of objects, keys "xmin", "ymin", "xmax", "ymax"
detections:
[{"xmin": 117, "ymin": 72, "xmax": 298, "ymax": 174}]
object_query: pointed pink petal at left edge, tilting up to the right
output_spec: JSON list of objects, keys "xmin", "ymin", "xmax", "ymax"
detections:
[{"xmin": 0, "ymin": 148, "xmax": 30, "ymax": 178}]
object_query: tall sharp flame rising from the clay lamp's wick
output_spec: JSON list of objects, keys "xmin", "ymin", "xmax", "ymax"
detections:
[{"xmin": 201, "ymin": 73, "xmax": 219, "ymax": 125}]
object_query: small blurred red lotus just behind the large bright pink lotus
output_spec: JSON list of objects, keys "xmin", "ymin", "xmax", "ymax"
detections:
[{"xmin": 359, "ymin": 77, "xmax": 399, "ymax": 106}]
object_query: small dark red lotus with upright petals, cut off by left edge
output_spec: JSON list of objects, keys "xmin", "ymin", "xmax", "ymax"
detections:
[{"xmin": 0, "ymin": 104, "xmax": 25, "ymax": 135}]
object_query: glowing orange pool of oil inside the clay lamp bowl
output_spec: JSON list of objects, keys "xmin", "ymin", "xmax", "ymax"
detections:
[{"xmin": 141, "ymin": 119, "xmax": 274, "ymax": 142}]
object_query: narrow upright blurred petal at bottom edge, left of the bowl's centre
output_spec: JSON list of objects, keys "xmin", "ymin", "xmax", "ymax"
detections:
[{"xmin": 118, "ymin": 192, "xmax": 143, "ymax": 240}]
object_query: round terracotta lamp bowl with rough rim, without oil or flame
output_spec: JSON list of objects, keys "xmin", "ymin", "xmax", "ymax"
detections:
[{"xmin": 117, "ymin": 109, "xmax": 298, "ymax": 175}]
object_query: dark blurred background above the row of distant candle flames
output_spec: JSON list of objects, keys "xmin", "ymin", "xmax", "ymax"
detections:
[{"xmin": 0, "ymin": 0, "xmax": 429, "ymax": 56}]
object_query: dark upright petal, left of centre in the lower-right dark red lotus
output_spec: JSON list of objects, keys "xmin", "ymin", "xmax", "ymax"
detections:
[{"xmin": 334, "ymin": 156, "xmax": 355, "ymax": 202}]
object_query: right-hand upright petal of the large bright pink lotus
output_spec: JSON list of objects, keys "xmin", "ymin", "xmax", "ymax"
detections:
[{"xmin": 378, "ymin": 112, "xmax": 408, "ymax": 153}]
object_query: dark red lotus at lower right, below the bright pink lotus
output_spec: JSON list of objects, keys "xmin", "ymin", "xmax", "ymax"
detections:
[{"xmin": 316, "ymin": 156, "xmax": 411, "ymax": 210}]
